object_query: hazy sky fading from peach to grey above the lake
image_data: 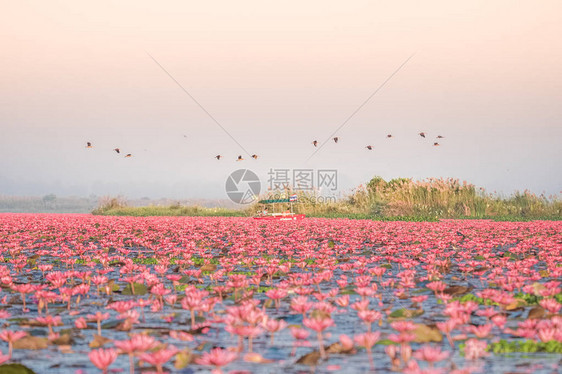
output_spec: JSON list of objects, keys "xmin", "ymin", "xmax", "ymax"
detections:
[{"xmin": 0, "ymin": 0, "xmax": 562, "ymax": 202}]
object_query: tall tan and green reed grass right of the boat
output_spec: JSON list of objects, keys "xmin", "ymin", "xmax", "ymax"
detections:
[{"xmin": 250, "ymin": 177, "xmax": 562, "ymax": 220}]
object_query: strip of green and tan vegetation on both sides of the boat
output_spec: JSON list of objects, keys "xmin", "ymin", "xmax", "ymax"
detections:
[{"xmin": 92, "ymin": 177, "xmax": 562, "ymax": 221}]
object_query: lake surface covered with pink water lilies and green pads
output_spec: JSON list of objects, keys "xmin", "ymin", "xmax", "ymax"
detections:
[{"xmin": 0, "ymin": 214, "xmax": 562, "ymax": 374}]
